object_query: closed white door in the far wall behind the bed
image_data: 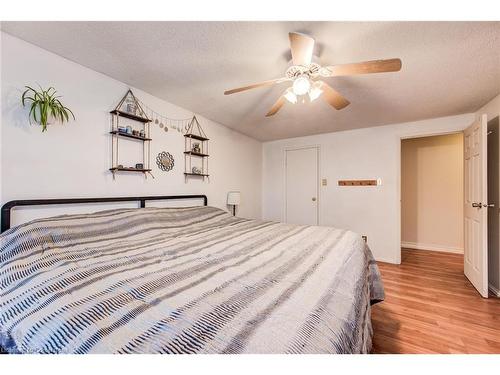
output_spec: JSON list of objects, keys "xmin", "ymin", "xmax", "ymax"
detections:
[{"xmin": 285, "ymin": 147, "xmax": 318, "ymax": 225}]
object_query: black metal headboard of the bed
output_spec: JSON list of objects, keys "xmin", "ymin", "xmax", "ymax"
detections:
[{"xmin": 1, "ymin": 195, "xmax": 208, "ymax": 232}]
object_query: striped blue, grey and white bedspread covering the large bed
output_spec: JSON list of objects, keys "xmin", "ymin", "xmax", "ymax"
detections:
[{"xmin": 0, "ymin": 207, "xmax": 384, "ymax": 353}]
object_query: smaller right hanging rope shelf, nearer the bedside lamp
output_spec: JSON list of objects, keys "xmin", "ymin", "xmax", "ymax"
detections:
[{"xmin": 184, "ymin": 116, "xmax": 209, "ymax": 182}]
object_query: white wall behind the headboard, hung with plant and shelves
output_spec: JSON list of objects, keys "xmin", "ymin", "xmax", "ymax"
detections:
[{"xmin": 0, "ymin": 33, "xmax": 262, "ymax": 225}]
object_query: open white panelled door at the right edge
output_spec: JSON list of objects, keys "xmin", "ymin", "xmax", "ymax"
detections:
[{"xmin": 464, "ymin": 115, "xmax": 488, "ymax": 298}]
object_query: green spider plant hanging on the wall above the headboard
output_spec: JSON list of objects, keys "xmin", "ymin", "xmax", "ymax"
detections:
[{"xmin": 21, "ymin": 86, "xmax": 75, "ymax": 132}]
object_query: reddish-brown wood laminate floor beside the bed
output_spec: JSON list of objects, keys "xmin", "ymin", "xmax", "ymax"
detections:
[{"xmin": 372, "ymin": 249, "xmax": 500, "ymax": 354}]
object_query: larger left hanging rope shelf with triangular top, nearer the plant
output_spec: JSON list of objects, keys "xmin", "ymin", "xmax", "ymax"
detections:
[{"xmin": 109, "ymin": 90, "xmax": 154, "ymax": 180}]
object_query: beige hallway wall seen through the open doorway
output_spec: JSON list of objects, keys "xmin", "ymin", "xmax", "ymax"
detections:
[{"xmin": 401, "ymin": 133, "xmax": 464, "ymax": 253}]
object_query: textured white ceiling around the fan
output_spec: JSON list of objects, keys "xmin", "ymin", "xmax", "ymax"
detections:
[{"xmin": 2, "ymin": 22, "xmax": 500, "ymax": 140}]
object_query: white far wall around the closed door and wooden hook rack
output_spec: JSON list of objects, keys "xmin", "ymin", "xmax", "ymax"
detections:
[{"xmin": 262, "ymin": 114, "xmax": 474, "ymax": 263}]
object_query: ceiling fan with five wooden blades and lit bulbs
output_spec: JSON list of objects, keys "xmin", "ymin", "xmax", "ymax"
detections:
[{"xmin": 224, "ymin": 32, "xmax": 401, "ymax": 117}]
